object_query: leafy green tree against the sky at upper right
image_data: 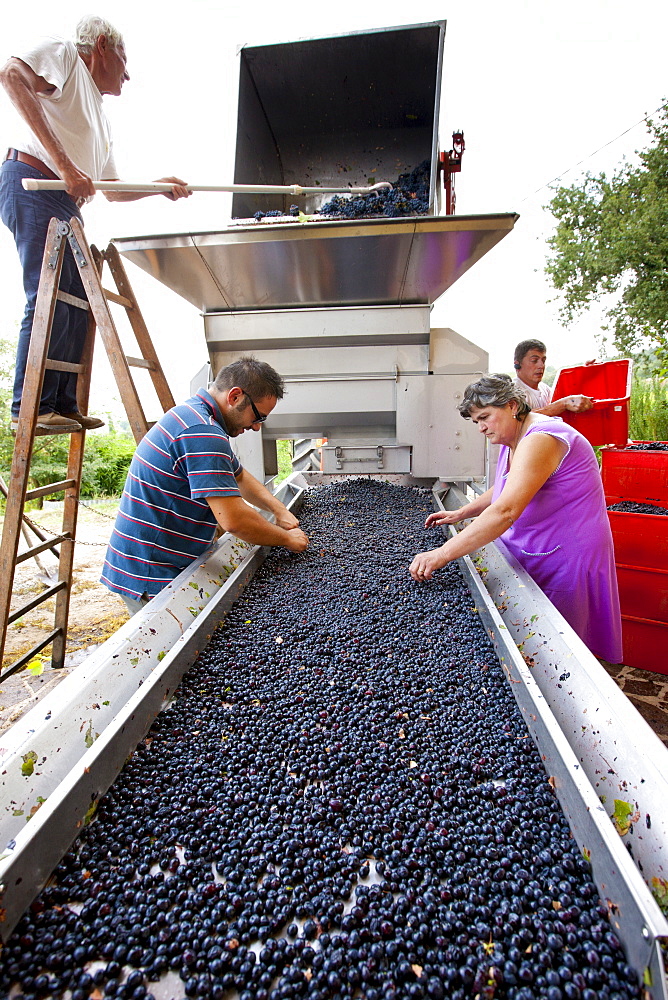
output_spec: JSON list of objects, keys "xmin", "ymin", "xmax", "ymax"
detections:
[{"xmin": 546, "ymin": 105, "xmax": 668, "ymax": 372}]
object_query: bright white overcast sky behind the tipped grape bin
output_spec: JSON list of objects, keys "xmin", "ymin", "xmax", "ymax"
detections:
[{"xmin": 0, "ymin": 0, "xmax": 668, "ymax": 410}]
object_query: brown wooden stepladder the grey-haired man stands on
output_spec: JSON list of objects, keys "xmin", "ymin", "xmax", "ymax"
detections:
[{"xmin": 0, "ymin": 218, "xmax": 174, "ymax": 682}]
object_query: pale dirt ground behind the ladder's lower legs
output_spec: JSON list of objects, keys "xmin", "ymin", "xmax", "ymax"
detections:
[{"xmin": 0, "ymin": 501, "xmax": 128, "ymax": 732}]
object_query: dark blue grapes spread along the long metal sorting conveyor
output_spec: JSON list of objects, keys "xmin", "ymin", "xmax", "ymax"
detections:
[{"xmin": 0, "ymin": 480, "xmax": 640, "ymax": 1000}]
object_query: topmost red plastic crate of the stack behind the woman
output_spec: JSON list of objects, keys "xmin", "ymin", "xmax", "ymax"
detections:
[{"xmin": 601, "ymin": 441, "xmax": 668, "ymax": 507}]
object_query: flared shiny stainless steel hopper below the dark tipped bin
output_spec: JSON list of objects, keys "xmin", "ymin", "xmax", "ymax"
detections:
[{"xmin": 114, "ymin": 213, "xmax": 518, "ymax": 313}]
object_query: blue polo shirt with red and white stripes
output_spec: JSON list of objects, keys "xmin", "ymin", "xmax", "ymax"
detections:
[{"xmin": 100, "ymin": 389, "xmax": 242, "ymax": 599}]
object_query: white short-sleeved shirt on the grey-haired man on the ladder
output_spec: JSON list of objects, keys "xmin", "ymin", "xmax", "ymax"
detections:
[{"xmin": 14, "ymin": 36, "xmax": 118, "ymax": 181}]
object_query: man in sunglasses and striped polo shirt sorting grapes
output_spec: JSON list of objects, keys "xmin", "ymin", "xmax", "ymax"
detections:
[{"xmin": 101, "ymin": 357, "xmax": 308, "ymax": 613}]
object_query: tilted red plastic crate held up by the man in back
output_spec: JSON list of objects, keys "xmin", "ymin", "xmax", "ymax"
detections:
[{"xmin": 552, "ymin": 358, "xmax": 633, "ymax": 448}]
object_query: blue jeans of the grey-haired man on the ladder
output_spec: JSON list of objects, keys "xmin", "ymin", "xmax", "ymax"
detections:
[{"xmin": 0, "ymin": 160, "xmax": 88, "ymax": 419}]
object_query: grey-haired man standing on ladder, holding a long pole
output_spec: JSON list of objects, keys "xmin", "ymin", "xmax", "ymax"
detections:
[{"xmin": 0, "ymin": 17, "xmax": 191, "ymax": 434}]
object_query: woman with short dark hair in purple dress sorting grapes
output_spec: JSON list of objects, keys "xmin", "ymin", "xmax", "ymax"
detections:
[{"xmin": 410, "ymin": 375, "xmax": 622, "ymax": 663}]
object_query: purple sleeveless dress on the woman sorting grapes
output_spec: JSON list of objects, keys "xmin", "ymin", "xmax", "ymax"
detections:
[{"xmin": 492, "ymin": 416, "xmax": 622, "ymax": 663}]
